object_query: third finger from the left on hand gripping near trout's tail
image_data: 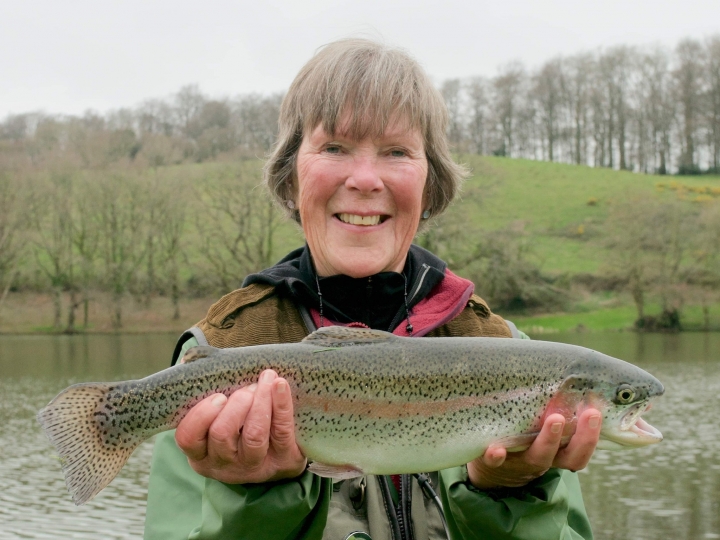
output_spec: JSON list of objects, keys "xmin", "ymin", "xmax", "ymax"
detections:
[{"xmin": 239, "ymin": 369, "xmax": 277, "ymax": 468}]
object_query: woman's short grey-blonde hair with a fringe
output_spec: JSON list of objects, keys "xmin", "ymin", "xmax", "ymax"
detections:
[{"xmin": 265, "ymin": 39, "xmax": 467, "ymax": 221}]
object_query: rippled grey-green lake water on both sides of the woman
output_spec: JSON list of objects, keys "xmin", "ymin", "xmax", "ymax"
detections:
[{"xmin": 0, "ymin": 333, "xmax": 720, "ymax": 540}]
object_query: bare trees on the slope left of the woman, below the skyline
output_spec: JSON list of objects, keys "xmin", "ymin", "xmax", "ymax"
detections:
[{"xmin": 0, "ymin": 160, "xmax": 290, "ymax": 332}]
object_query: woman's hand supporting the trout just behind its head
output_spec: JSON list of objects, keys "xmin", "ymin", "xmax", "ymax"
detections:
[{"xmin": 468, "ymin": 409, "xmax": 602, "ymax": 489}]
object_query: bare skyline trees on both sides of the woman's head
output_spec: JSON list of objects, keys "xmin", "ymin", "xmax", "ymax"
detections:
[{"xmin": 0, "ymin": 35, "xmax": 720, "ymax": 174}]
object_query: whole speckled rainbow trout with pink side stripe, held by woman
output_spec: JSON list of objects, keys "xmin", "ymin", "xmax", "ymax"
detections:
[{"xmin": 38, "ymin": 327, "xmax": 663, "ymax": 505}]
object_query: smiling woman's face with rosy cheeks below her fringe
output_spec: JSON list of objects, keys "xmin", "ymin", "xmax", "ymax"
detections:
[{"xmin": 294, "ymin": 118, "xmax": 428, "ymax": 277}]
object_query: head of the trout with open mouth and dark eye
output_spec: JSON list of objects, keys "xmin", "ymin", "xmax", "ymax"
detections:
[{"xmin": 558, "ymin": 351, "xmax": 665, "ymax": 450}]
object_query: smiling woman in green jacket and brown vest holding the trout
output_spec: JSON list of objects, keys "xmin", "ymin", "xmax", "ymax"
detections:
[{"xmin": 146, "ymin": 40, "xmax": 601, "ymax": 540}]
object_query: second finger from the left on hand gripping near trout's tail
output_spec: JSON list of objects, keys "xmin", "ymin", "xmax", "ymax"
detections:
[{"xmin": 207, "ymin": 384, "xmax": 257, "ymax": 465}]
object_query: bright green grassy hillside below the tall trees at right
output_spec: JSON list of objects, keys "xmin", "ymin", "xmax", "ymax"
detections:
[{"xmin": 452, "ymin": 155, "xmax": 720, "ymax": 274}]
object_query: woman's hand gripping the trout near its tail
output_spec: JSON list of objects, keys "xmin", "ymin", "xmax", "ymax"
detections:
[{"xmin": 175, "ymin": 370, "xmax": 307, "ymax": 484}]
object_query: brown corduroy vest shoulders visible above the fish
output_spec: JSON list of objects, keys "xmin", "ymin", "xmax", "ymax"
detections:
[{"xmin": 196, "ymin": 283, "xmax": 512, "ymax": 348}]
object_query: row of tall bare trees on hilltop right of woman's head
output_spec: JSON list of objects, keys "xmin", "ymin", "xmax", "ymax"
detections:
[{"xmin": 441, "ymin": 35, "xmax": 720, "ymax": 174}]
